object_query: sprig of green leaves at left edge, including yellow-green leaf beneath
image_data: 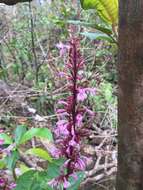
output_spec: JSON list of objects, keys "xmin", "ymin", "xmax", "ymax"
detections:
[{"xmin": 0, "ymin": 125, "xmax": 53, "ymax": 174}]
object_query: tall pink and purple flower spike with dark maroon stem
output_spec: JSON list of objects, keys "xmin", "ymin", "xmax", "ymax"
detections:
[{"xmin": 49, "ymin": 38, "xmax": 95, "ymax": 189}]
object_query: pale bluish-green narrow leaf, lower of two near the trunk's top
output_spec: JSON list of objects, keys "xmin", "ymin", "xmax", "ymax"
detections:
[{"xmin": 80, "ymin": 32, "xmax": 114, "ymax": 43}]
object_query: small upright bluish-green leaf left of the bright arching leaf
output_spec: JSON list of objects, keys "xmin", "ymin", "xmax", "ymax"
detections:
[{"xmin": 14, "ymin": 125, "xmax": 26, "ymax": 145}]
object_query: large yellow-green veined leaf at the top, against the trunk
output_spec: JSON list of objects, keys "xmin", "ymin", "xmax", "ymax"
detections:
[{"xmin": 80, "ymin": 0, "xmax": 118, "ymax": 25}]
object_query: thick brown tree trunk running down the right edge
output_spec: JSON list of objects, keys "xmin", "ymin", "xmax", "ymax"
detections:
[{"xmin": 116, "ymin": 0, "xmax": 143, "ymax": 190}]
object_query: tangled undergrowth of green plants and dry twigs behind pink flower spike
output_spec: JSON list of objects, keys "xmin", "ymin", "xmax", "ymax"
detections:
[{"xmin": 0, "ymin": 0, "xmax": 117, "ymax": 190}]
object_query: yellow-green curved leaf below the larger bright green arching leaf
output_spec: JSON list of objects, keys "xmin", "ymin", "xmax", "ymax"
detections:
[{"xmin": 26, "ymin": 148, "xmax": 52, "ymax": 162}]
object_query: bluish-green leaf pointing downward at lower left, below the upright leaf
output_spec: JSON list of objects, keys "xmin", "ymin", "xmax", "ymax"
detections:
[{"xmin": 5, "ymin": 150, "xmax": 20, "ymax": 170}]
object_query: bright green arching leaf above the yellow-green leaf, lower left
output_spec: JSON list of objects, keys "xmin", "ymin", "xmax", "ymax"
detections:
[{"xmin": 20, "ymin": 128, "xmax": 53, "ymax": 144}]
